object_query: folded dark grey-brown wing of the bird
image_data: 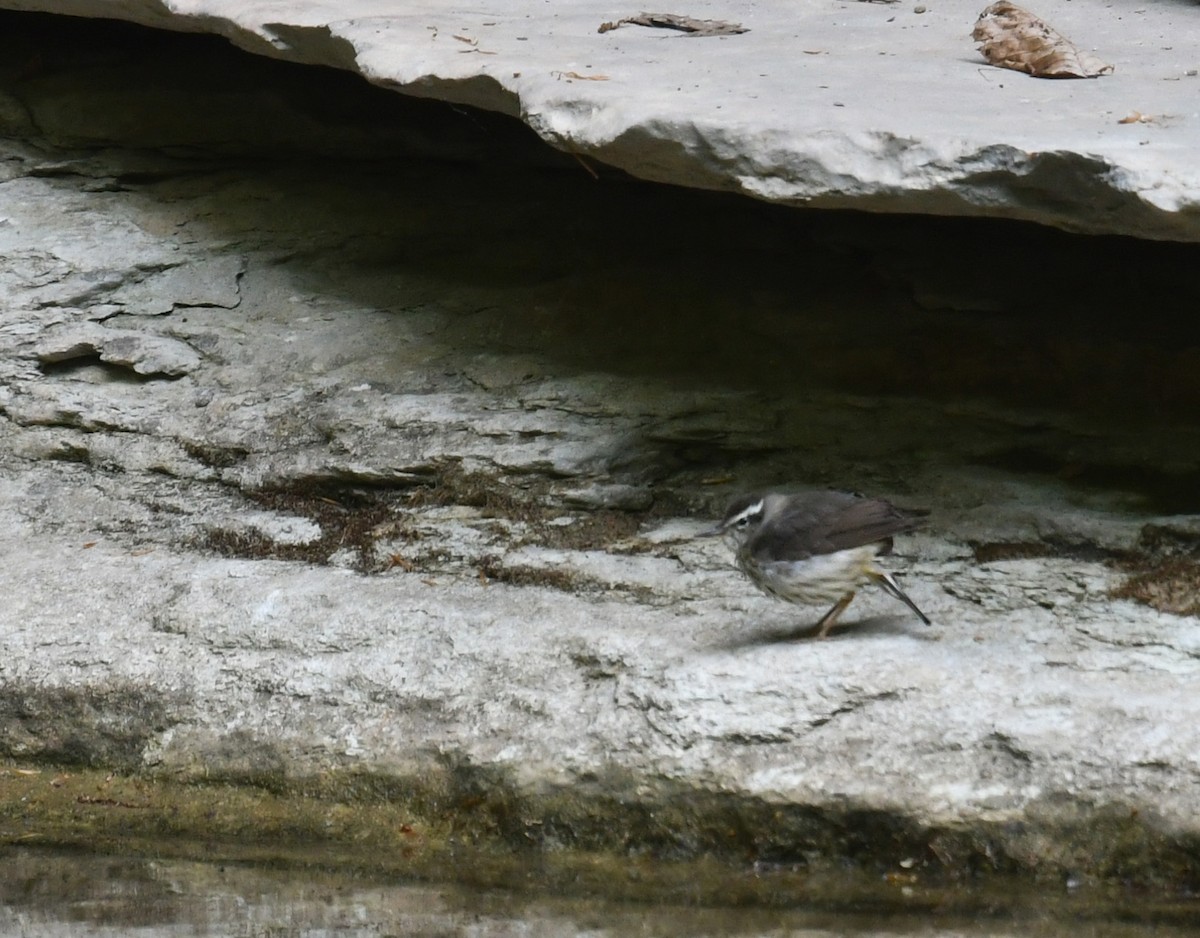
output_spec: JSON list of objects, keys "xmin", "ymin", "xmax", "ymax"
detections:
[{"xmin": 746, "ymin": 492, "xmax": 922, "ymax": 561}]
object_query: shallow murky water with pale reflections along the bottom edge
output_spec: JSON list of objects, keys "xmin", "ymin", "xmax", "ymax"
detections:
[{"xmin": 0, "ymin": 848, "xmax": 1195, "ymax": 938}]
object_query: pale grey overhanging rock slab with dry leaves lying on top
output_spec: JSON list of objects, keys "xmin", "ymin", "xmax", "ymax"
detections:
[{"xmin": 0, "ymin": 0, "xmax": 1200, "ymax": 241}]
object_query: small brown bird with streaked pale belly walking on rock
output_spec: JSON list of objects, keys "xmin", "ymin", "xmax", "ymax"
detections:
[{"xmin": 704, "ymin": 491, "xmax": 930, "ymax": 638}]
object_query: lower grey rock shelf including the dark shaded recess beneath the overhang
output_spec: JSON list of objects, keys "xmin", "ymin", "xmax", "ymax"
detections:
[{"xmin": 0, "ymin": 9, "xmax": 1200, "ymax": 877}]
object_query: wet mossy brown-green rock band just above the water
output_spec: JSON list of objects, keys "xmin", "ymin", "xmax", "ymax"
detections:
[{"xmin": 0, "ymin": 758, "xmax": 1200, "ymax": 922}]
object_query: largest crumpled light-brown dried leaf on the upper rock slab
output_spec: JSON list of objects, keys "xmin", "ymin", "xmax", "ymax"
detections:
[{"xmin": 971, "ymin": 0, "xmax": 1112, "ymax": 78}]
